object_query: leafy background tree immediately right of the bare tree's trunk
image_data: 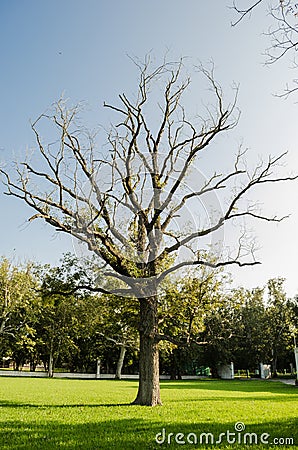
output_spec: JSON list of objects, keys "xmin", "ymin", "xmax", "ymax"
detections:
[{"xmin": 159, "ymin": 266, "xmax": 226, "ymax": 379}]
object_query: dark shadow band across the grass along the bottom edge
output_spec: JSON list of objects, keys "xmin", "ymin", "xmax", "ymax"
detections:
[{"xmin": 0, "ymin": 418, "xmax": 298, "ymax": 450}]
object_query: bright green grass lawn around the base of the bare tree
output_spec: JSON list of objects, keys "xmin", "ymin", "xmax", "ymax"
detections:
[{"xmin": 0, "ymin": 377, "xmax": 298, "ymax": 450}]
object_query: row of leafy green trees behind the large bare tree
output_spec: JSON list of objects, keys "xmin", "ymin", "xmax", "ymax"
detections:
[{"xmin": 0, "ymin": 254, "xmax": 298, "ymax": 378}]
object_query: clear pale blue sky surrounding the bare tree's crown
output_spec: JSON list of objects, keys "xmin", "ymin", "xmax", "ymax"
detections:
[{"xmin": 0, "ymin": 0, "xmax": 298, "ymax": 296}]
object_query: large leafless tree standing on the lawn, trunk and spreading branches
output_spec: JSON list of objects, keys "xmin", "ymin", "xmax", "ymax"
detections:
[{"xmin": 1, "ymin": 58, "xmax": 295, "ymax": 405}]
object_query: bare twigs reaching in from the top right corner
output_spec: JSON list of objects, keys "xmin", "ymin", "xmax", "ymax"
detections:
[{"xmin": 232, "ymin": 0, "xmax": 298, "ymax": 97}]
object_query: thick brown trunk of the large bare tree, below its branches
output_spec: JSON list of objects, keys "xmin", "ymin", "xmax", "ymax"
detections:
[{"xmin": 133, "ymin": 297, "xmax": 162, "ymax": 406}]
